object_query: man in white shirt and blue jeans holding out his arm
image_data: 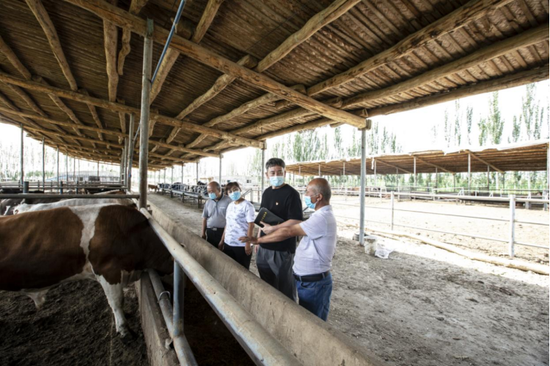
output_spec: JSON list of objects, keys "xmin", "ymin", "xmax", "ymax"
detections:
[{"xmin": 240, "ymin": 178, "xmax": 337, "ymax": 321}]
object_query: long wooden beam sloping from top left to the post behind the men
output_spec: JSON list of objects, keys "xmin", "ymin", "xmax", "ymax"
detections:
[{"xmin": 65, "ymin": 0, "xmax": 366, "ymax": 128}]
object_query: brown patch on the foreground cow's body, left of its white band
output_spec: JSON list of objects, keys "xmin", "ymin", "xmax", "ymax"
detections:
[{"xmin": 0, "ymin": 207, "xmax": 86, "ymax": 291}]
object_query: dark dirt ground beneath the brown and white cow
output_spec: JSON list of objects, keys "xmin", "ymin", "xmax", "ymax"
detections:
[{"xmin": 0, "ymin": 281, "xmax": 148, "ymax": 366}]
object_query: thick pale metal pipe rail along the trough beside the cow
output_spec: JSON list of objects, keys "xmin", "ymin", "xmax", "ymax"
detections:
[{"xmin": 141, "ymin": 208, "xmax": 300, "ymax": 365}]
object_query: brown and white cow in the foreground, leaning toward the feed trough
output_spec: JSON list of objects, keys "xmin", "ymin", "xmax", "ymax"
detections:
[{"xmin": 0, "ymin": 205, "xmax": 173, "ymax": 337}]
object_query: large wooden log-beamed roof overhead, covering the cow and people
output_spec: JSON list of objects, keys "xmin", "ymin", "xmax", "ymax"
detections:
[{"xmin": 0, "ymin": 0, "xmax": 549, "ymax": 167}]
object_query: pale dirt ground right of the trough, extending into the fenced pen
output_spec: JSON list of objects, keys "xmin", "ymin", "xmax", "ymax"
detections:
[{"xmin": 150, "ymin": 195, "xmax": 549, "ymax": 366}]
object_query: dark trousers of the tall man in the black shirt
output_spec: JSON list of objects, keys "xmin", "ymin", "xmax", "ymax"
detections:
[{"xmin": 256, "ymin": 247, "xmax": 296, "ymax": 301}]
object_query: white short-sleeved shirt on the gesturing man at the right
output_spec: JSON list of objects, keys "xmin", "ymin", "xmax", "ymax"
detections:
[{"xmin": 292, "ymin": 205, "xmax": 336, "ymax": 276}]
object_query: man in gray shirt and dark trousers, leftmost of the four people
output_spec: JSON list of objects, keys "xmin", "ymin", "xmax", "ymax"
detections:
[{"xmin": 201, "ymin": 181, "xmax": 231, "ymax": 248}]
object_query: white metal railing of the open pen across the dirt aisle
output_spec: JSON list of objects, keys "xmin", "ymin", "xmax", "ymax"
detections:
[{"xmin": 336, "ymin": 192, "xmax": 549, "ymax": 258}]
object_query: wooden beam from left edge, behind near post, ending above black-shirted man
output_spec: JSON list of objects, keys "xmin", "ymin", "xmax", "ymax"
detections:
[{"xmin": 0, "ymin": 72, "xmax": 264, "ymax": 148}]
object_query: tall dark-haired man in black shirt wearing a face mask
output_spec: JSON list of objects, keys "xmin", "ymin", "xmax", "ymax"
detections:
[{"xmin": 256, "ymin": 158, "xmax": 303, "ymax": 301}]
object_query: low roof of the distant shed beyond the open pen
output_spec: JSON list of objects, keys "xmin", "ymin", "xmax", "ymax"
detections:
[{"xmin": 286, "ymin": 140, "xmax": 548, "ymax": 176}]
